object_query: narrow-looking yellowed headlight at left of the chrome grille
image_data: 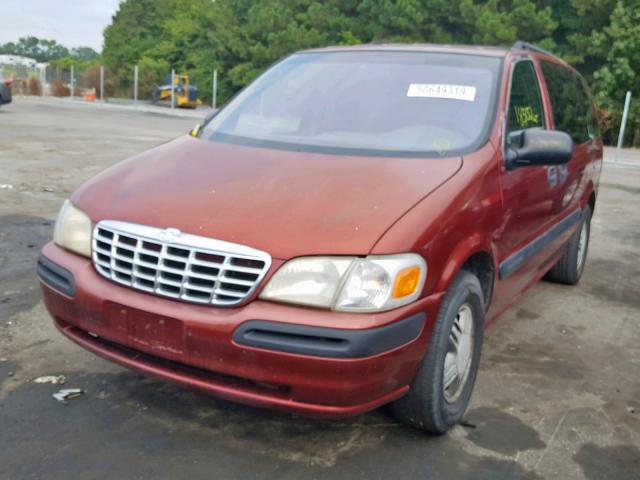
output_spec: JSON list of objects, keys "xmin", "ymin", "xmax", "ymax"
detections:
[{"xmin": 53, "ymin": 200, "xmax": 91, "ymax": 257}]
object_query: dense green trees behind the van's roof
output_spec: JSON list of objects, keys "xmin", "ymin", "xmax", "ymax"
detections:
[{"xmin": 86, "ymin": 0, "xmax": 640, "ymax": 144}]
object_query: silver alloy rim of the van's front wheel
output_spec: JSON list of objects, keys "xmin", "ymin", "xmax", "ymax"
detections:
[{"xmin": 442, "ymin": 303, "xmax": 474, "ymax": 403}]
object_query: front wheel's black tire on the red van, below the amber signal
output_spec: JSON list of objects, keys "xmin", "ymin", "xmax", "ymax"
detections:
[{"xmin": 391, "ymin": 270, "xmax": 485, "ymax": 434}]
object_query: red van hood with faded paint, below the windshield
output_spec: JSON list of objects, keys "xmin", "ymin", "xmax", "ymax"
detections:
[{"xmin": 71, "ymin": 136, "xmax": 462, "ymax": 259}]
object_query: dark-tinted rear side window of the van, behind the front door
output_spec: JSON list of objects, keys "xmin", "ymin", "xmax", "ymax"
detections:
[{"xmin": 540, "ymin": 61, "xmax": 598, "ymax": 145}]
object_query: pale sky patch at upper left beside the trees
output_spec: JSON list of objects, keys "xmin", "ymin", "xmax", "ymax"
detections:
[{"xmin": 0, "ymin": 0, "xmax": 121, "ymax": 52}]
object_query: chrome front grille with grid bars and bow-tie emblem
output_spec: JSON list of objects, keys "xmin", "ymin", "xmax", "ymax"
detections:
[{"xmin": 93, "ymin": 220, "xmax": 271, "ymax": 306}]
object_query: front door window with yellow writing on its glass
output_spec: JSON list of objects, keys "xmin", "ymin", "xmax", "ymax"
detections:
[{"xmin": 507, "ymin": 61, "xmax": 545, "ymax": 147}]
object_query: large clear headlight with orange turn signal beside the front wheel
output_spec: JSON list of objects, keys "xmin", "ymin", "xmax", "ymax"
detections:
[{"xmin": 260, "ymin": 253, "xmax": 427, "ymax": 312}]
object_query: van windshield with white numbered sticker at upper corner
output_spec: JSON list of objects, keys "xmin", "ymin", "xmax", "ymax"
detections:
[{"xmin": 202, "ymin": 51, "xmax": 501, "ymax": 156}]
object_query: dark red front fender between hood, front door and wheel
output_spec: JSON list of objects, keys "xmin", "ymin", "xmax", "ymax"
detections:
[{"xmin": 371, "ymin": 144, "xmax": 503, "ymax": 296}]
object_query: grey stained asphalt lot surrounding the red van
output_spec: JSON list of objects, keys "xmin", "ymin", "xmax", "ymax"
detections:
[{"xmin": 0, "ymin": 99, "xmax": 640, "ymax": 480}]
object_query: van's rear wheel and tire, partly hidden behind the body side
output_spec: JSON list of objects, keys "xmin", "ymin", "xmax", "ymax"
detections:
[{"xmin": 546, "ymin": 205, "xmax": 592, "ymax": 285}]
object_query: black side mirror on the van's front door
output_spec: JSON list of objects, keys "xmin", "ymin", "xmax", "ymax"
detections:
[{"xmin": 506, "ymin": 128, "xmax": 573, "ymax": 168}]
